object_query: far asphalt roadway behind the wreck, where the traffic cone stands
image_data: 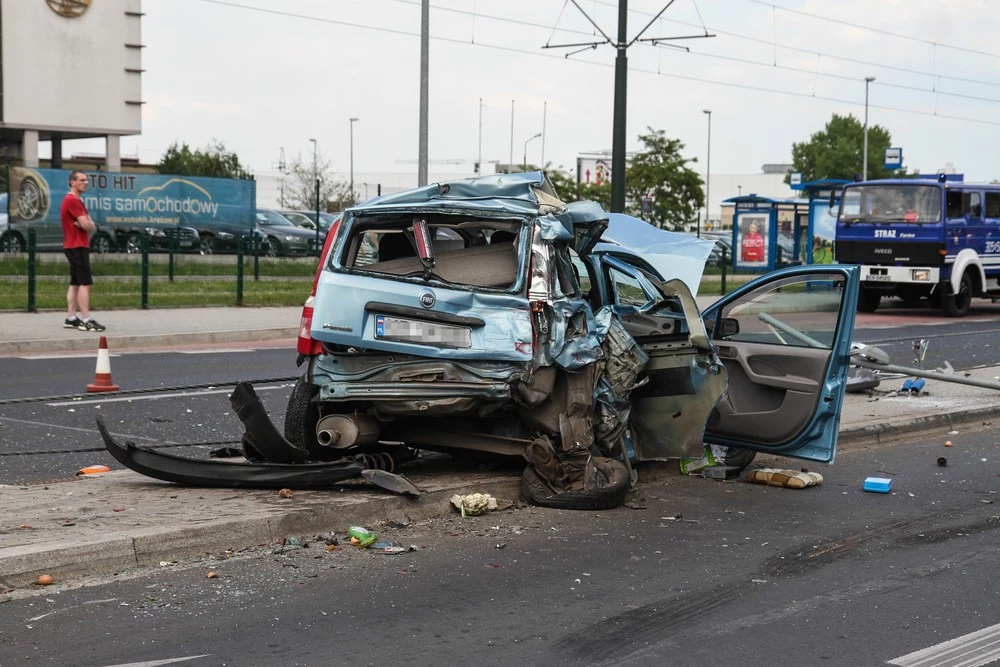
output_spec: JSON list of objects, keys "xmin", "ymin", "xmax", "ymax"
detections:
[{"xmin": 0, "ymin": 309, "xmax": 1000, "ymax": 484}]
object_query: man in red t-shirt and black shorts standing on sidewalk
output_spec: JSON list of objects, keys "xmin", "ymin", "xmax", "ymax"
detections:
[{"xmin": 59, "ymin": 170, "xmax": 105, "ymax": 331}]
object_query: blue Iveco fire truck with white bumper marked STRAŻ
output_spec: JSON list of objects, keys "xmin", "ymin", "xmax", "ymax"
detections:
[{"xmin": 835, "ymin": 176, "xmax": 1000, "ymax": 317}]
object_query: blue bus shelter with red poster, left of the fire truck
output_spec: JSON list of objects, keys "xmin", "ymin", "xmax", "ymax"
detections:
[{"xmin": 725, "ymin": 194, "xmax": 811, "ymax": 273}]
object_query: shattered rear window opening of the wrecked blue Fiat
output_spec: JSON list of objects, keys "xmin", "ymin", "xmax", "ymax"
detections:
[{"xmin": 343, "ymin": 216, "xmax": 523, "ymax": 289}]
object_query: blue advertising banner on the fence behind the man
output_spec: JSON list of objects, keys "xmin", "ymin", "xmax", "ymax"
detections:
[{"xmin": 10, "ymin": 167, "xmax": 256, "ymax": 228}]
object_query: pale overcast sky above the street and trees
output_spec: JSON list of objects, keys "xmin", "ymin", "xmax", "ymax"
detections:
[{"xmin": 58, "ymin": 0, "xmax": 1000, "ymax": 180}]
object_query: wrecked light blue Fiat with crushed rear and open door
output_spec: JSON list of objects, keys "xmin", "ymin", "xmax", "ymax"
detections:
[{"xmin": 285, "ymin": 173, "xmax": 858, "ymax": 509}]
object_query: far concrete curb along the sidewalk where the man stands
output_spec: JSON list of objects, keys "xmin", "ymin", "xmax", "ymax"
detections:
[{"xmin": 0, "ymin": 327, "xmax": 299, "ymax": 354}]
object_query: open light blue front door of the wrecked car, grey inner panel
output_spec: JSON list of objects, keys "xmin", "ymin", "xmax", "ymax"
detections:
[{"xmin": 702, "ymin": 264, "xmax": 859, "ymax": 462}]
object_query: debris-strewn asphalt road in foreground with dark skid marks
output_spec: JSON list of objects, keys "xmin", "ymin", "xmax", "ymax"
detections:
[{"xmin": 0, "ymin": 422, "xmax": 1000, "ymax": 667}]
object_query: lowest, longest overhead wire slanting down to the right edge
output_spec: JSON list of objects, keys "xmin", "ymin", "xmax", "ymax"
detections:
[{"xmin": 199, "ymin": 0, "xmax": 1000, "ymax": 126}]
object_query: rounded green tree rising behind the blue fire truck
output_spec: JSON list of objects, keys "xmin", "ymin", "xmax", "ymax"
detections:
[{"xmin": 785, "ymin": 114, "xmax": 906, "ymax": 183}]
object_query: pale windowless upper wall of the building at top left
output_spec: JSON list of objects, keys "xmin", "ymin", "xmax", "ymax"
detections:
[{"xmin": 0, "ymin": 0, "xmax": 142, "ymax": 135}]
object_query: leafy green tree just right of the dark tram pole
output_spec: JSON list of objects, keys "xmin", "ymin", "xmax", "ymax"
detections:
[{"xmin": 624, "ymin": 128, "xmax": 705, "ymax": 229}]
